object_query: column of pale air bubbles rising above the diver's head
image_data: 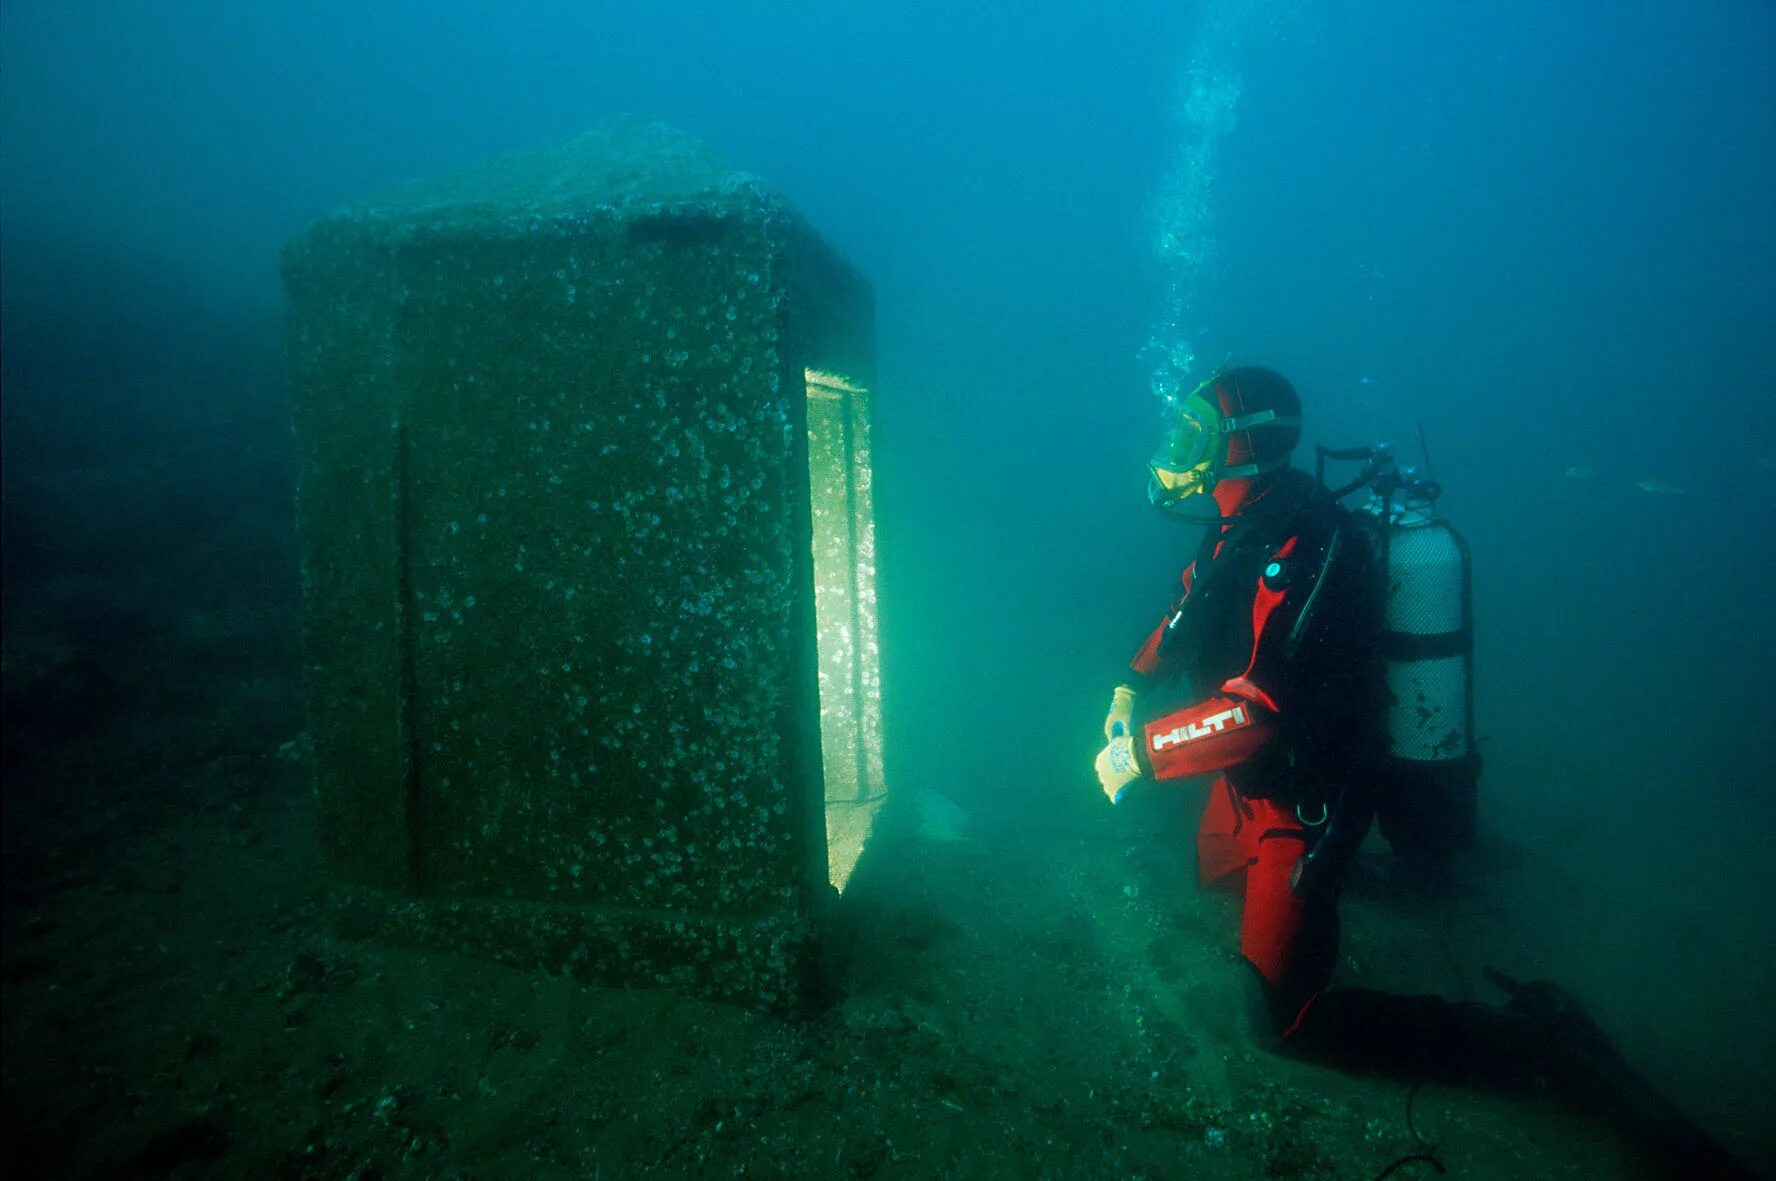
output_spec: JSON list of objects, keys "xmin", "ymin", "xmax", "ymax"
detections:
[{"xmin": 1146, "ymin": 0, "xmax": 1268, "ymax": 408}]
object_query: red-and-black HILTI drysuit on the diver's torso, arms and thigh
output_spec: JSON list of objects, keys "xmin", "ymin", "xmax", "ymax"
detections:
[{"xmin": 1130, "ymin": 472, "xmax": 1376, "ymax": 1032}]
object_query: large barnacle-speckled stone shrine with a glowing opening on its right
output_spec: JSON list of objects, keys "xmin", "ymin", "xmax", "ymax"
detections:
[{"xmin": 282, "ymin": 121, "xmax": 883, "ymax": 1003}]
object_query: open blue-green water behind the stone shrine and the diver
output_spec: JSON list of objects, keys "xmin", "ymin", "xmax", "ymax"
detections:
[{"xmin": 0, "ymin": 0, "xmax": 1776, "ymax": 1136}]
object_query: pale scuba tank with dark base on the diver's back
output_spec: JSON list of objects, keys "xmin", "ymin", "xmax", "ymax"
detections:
[{"xmin": 1320, "ymin": 432, "xmax": 1479, "ymax": 868}]
